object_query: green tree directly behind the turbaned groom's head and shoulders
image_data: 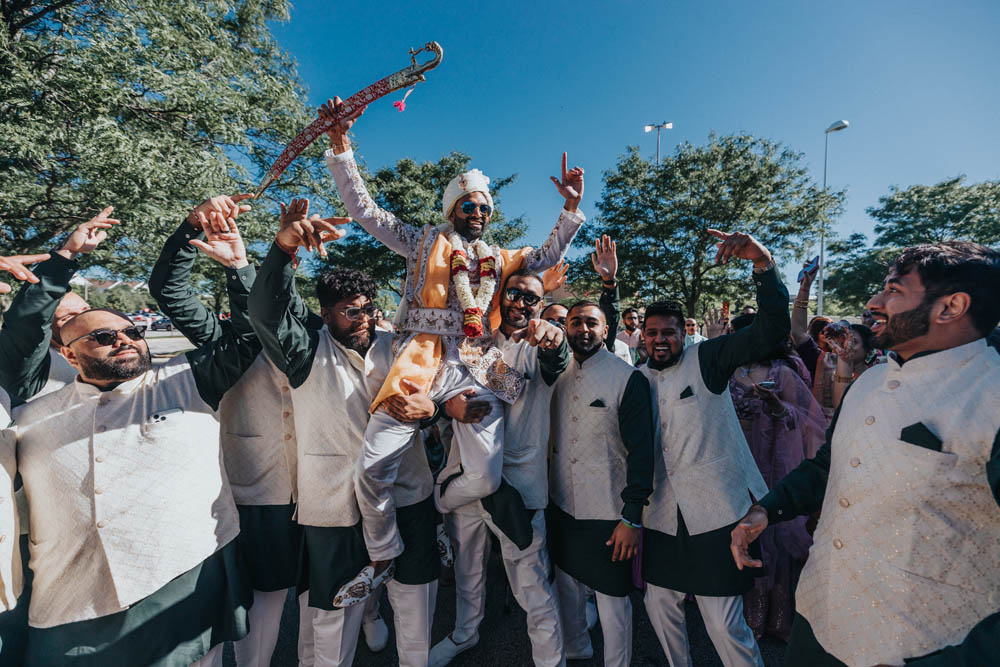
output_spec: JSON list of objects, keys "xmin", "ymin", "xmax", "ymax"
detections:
[{"xmin": 316, "ymin": 152, "xmax": 527, "ymax": 296}]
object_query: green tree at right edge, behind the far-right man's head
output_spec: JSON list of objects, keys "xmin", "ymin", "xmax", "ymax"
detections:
[{"xmin": 826, "ymin": 176, "xmax": 1000, "ymax": 313}]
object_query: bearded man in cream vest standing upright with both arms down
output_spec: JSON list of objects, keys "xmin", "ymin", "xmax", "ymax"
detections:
[{"xmin": 548, "ymin": 301, "xmax": 653, "ymax": 666}]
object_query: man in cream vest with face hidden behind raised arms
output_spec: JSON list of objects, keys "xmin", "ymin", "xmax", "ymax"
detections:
[{"xmin": 149, "ymin": 194, "xmax": 328, "ymax": 667}]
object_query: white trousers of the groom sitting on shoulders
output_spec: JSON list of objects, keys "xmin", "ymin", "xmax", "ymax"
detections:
[{"xmin": 354, "ymin": 365, "xmax": 503, "ymax": 561}]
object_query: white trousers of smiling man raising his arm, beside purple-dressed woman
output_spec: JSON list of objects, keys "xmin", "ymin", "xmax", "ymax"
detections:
[{"xmin": 644, "ymin": 583, "xmax": 764, "ymax": 667}]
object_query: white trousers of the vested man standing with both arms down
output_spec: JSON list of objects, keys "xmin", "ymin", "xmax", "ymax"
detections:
[{"xmin": 556, "ymin": 567, "xmax": 632, "ymax": 667}]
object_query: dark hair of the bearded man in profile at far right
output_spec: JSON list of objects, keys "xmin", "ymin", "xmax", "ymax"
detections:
[{"xmin": 892, "ymin": 241, "xmax": 1000, "ymax": 336}]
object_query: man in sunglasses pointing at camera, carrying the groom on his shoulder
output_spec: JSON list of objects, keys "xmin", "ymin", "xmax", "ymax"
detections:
[{"xmin": 428, "ymin": 269, "xmax": 569, "ymax": 667}]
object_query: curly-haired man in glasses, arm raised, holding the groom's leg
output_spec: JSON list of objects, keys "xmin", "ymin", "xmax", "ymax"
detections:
[{"xmin": 250, "ymin": 200, "xmax": 440, "ymax": 665}]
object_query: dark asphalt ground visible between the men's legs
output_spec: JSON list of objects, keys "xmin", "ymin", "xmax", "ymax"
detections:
[{"xmin": 225, "ymin": 540, "xmax": 784, "ymax": 667}]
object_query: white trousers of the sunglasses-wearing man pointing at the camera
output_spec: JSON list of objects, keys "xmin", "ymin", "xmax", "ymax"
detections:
[{"xmin": 445, "ymin": 502, "xmax": 566, "ymax": 667}]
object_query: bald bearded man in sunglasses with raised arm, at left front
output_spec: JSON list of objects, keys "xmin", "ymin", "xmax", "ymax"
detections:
[{"xmin": 3, "ymin": 217, "xmax": 260, "ymax": 666}]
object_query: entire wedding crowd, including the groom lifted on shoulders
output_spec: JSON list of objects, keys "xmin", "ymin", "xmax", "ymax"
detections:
[{"xmin": 0, "ymin": 100, "xmax": 1000, "ymax": 666}]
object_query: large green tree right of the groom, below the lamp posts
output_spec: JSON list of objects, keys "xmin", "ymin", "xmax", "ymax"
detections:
[{"xmin": 571, "ymin": 133, "xmax": 844, "ymax": 316}]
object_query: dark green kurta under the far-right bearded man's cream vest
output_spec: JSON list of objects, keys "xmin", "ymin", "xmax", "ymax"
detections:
[{"xmin": 760, "ymin": 352, "xmax": 1000, "ymax": 667}]
